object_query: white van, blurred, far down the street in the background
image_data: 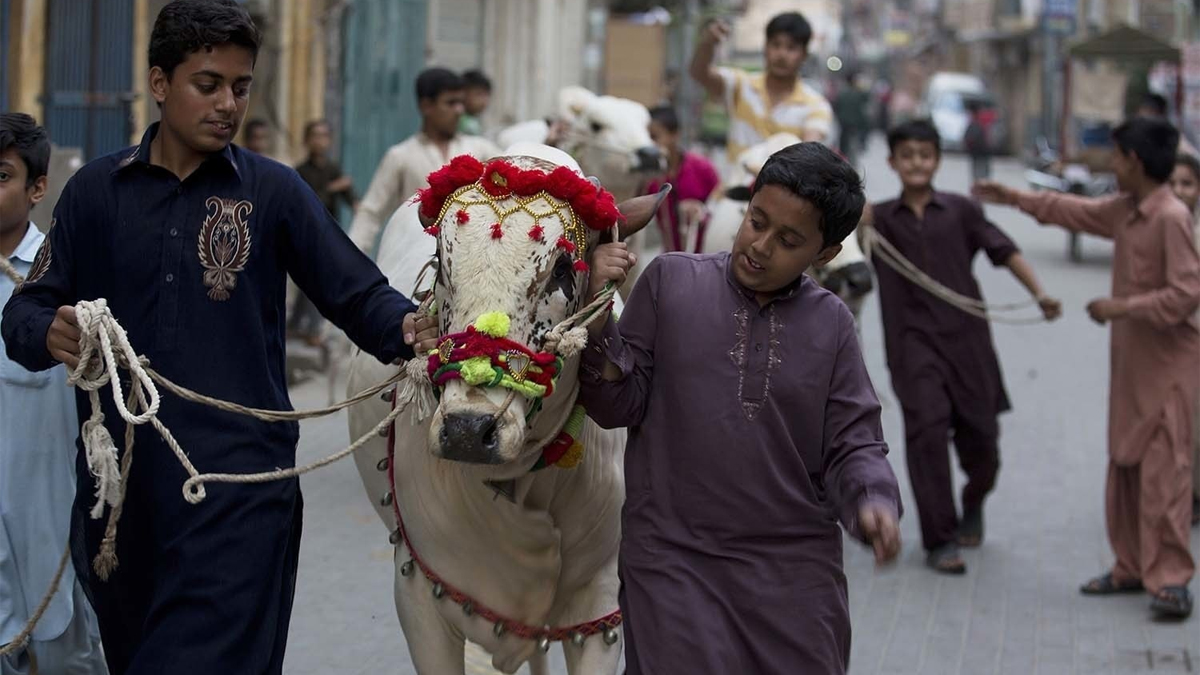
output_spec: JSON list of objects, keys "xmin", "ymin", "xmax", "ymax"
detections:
[{"xmin": 922, "ymin": 72, "xmax": 1008, "ymax": 154}]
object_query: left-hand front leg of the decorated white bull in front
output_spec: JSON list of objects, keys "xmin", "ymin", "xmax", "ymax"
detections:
[{"xmin": 395, "ymin": 546, "xmax": 464, "ymax": 675}]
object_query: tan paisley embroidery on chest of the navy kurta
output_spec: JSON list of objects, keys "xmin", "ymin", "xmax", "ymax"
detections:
[{"xmin": 198, "ymin": 197, "xmax": 254, "ymax": 301}]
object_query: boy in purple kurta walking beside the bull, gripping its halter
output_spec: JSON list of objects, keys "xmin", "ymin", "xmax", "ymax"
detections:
[{"xmin": 580, "ymin": 143, "xmax": 900, "ymax": 675}]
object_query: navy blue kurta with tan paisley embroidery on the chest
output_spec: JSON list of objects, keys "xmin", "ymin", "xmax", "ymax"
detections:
[{"xmin": 2, "ymin": 125, "xmax": 415, "ymax": 673}]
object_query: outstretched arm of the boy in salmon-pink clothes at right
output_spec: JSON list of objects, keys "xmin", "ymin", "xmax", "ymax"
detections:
[{"xmin": 971, "ymin": 180, "xmax": 1133, "ymax": 239}]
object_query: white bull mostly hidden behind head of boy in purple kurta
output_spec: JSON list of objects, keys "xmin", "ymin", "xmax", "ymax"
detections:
[{"xmin": 701, "ymin": 133, "xmax": 872, "ymax": 321}]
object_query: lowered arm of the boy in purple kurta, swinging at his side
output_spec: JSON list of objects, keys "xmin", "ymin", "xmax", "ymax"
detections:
[{"xmin": 821, "ymin": 307, "xmax": 901, "ymax": 563}]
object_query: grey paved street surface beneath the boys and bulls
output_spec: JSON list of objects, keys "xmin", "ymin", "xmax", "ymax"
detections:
[{"xmin": 286, "ymin": 139, "xmax": 1200, "ymax": 675}]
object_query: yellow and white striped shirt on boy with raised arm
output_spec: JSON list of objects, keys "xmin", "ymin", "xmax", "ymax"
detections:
[{"xmin": 719, "ymin": 68, "xmax": 833, "ymax": 161}]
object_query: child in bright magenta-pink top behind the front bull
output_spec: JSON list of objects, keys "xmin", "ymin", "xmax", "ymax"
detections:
[{"xmin": 647, "ymin": 106, "xmax": 721, "ymax": 253}]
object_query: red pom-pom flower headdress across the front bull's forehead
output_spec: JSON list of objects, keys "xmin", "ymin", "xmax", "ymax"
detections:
[{"xmin": 416, "ymin": 155, "xmax": 624, "ymax": 269}]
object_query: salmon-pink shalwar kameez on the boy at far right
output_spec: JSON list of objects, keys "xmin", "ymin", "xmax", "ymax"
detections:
[{"xmin": 1018, "ymin": 185, "xmax": 1200, "ymax": 593}]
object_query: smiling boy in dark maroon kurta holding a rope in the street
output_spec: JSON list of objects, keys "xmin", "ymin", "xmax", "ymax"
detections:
[{"xmin": 872, "ymin": 121, "xmax": 1060, "ymax": 574}]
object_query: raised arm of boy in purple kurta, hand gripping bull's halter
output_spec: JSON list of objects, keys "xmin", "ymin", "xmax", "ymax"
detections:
[{"xmin": 580, "ymin": 244, "xmax": 661, "ymax": 429}]
